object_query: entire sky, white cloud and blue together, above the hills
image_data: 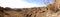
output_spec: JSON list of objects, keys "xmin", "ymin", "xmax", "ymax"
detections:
[{"xmin": 0, "ymin": 0, "xmax": 53, "ymax": 8}]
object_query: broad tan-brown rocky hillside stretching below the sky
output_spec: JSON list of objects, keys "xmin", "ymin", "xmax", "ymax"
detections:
[{"xmin": 4, "ymin": 4, "xmax": 60, "ymax": 17}]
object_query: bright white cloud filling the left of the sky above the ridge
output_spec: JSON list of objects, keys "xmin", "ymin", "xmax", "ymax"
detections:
[{"xmin": 0, "ymin": 0, "xmax": 46, "ymax": 8}]
